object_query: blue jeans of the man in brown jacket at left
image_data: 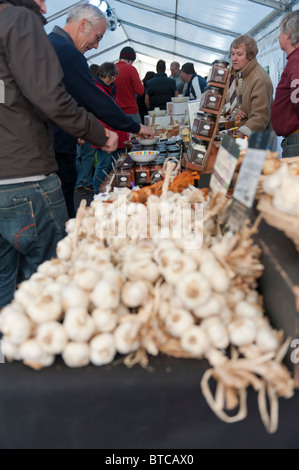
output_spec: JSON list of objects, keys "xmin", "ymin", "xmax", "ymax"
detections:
[{"xmin": 0, "ymin": 174, "xmax": 68, "ymax": 308}]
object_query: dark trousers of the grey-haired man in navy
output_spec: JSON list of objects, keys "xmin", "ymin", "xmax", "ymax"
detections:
[{"xmin": 55, "ymin": 153, "xmax": 77, "ymax": 219}]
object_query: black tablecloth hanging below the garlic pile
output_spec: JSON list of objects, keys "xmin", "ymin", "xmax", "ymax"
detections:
[{"xmin": 0, "ymin": 355, "xmax": 299, "ymax": 449}]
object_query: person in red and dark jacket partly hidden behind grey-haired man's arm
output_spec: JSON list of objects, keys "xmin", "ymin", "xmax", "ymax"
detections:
[{"xmin": 89, "ymin": 62, "xmax": 130, "ymax": 194}]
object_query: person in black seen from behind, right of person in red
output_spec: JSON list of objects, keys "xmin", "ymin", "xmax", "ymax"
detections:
[{"xmin": 145, "ymin": 60, "xmax": 178, "ymax": 110}]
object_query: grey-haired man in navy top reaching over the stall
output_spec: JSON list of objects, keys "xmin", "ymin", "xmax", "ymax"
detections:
[{"xmin": 49, "ymin": 3, "xmax": 153, "ymax": 217}]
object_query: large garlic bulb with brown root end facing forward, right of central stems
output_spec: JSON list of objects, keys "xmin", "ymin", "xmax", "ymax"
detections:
[{"xmin": 177, "ymin": 272, "xmax": 212, "ymax": 310}]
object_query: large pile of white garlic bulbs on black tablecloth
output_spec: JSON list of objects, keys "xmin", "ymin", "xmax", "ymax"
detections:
[{"xmin": 0, "ymin": 189, "xmax": 293, "ymax": 434}]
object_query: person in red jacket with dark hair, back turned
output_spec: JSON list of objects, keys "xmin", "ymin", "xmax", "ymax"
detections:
[{"xmin": 115, "ymin": 46, "xmax": 144, "ymax": 124}]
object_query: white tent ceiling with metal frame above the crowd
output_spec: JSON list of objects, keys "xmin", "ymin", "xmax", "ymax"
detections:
[{"xmin": 46, "ymin": 0, "xmax": 298, "ymax": 78}]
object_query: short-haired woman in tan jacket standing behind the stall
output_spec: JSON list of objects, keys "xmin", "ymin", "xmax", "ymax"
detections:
[{"xmin": 227, "ymin": 35, "xmax": 273, "ymax": 137}]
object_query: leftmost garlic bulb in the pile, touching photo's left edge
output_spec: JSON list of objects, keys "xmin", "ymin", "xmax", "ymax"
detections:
[{"xmin": 1, "ymin": 312, "xmax": 32, "ymax": 346}]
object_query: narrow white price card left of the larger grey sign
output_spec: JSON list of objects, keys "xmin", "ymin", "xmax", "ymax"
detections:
[{"xmin": 210, "ymin": 135, "xmax": 240, "ymax": 194}]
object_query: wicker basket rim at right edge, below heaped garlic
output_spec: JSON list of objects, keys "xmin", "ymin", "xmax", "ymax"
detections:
[{"xmin": 257, "ymin": 195, "xmax": 299, "ymax": 251}]
